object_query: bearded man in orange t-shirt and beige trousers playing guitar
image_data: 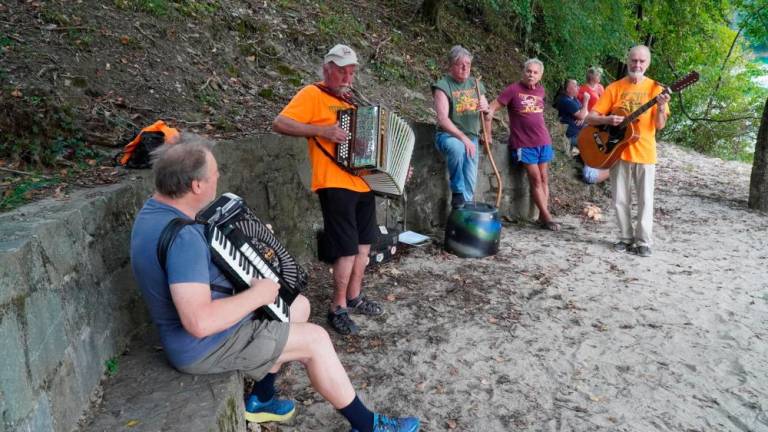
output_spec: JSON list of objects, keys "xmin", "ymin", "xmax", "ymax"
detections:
[{"xmin": 585, "ymin": 45, "xmax": 670, "ymax": 257}]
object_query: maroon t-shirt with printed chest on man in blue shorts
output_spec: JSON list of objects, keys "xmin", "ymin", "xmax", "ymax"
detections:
[{"xmin": 497, "ymin": 82, "xmax": 552, "ymax": 149}]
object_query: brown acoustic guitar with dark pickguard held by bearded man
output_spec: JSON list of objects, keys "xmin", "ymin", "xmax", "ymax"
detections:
[{"xmin": 578, "ymin": 71, "xmax": 699, "ymax": 169}]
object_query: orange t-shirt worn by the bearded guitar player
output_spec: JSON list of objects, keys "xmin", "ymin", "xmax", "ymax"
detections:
[{"xmin": 593, "ymin": 77, "xmax": 669, "ymax": 164}]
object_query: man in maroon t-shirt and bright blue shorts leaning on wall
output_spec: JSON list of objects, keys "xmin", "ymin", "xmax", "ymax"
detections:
[{"xmin": 485, "ymin": 58, "xmax": 560, "ymax": 231}]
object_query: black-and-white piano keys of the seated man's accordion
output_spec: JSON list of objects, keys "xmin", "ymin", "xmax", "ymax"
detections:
[{"xmin": 210, "ymin": 227, "xmax": 290, "ymax": 322}]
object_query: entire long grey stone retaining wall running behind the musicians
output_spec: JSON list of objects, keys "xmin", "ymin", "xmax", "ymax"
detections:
[{"xmin": 0, "ymin": 124, "xmax": 530, "ymax": 432}]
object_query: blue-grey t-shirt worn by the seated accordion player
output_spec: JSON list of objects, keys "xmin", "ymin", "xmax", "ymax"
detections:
[{"xmin": 131, "ymin": 198, "xmax": 252, "ymax": 367}]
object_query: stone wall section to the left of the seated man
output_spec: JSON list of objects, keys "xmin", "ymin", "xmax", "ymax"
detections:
[{"xmin": 0, "ymin": 179, "xmax": 149, "ymax": 432}]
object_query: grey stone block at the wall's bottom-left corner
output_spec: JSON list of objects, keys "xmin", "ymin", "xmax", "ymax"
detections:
[{"xmin": 0, "ymin": 311, "xmax": 35, "ymax": 427}]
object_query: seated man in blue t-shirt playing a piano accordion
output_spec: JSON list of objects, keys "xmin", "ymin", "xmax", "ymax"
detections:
[{"xmin": 131, "ymin": 135, "xmax": 419, "ymax": 432}]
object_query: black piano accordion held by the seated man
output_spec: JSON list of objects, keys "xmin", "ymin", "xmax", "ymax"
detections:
[{"xmin": 195, "ymin": 193, "xmax": 307, "ymax": 322}]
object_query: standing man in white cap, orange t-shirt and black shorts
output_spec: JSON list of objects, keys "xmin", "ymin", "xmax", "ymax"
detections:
[{"xmin": 272, "ymin": 45, "xmax": 383, "ymax": 334}]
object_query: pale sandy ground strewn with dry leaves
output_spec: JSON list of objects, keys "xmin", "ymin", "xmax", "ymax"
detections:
[{"xmin": 265, "ymin": 145, "xmax": 768, "ymax": 432}]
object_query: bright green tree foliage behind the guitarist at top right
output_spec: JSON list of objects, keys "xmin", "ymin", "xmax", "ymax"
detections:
[{"xmin": 454, "ymin": 0, "xmax": 768, "ymax": 160}]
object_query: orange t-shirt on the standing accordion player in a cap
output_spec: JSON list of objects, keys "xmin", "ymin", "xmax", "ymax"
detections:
[{"xmin": 280, "ymin": 85, "xmax": 371, "ymax": 192}]
